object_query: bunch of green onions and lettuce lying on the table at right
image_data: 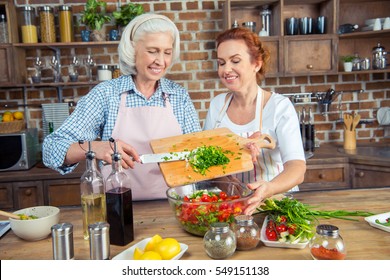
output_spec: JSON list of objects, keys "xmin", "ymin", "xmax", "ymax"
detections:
[{"xmin": 254, "ymin": 197, "xmax": 373, "ymax": 240}]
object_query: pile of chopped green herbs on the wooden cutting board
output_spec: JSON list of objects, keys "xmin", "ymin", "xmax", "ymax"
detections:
[{"xmin": 188, "ymin": 145, "xmax": 231, "ymax": 175}]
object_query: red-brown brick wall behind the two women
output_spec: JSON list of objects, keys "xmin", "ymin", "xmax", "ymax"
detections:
[{"xmin": 0, "ymin": 0, "xmax": 390, "ymax": 147}]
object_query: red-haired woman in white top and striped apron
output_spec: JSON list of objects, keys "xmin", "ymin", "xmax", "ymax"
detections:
[{"xmin": 204, "ymin": 28, "xmax": 306, "ymax": 214}]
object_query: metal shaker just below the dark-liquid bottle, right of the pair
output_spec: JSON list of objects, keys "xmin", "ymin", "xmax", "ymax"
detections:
[{"xmin": 88, "ymin": 222, "xmax": 110, "ymax": 260}]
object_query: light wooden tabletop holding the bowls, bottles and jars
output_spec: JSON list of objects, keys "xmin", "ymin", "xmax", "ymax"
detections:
[{"xmin": 0, "ymin": 188, "xmax": 390, "ymax": 260}]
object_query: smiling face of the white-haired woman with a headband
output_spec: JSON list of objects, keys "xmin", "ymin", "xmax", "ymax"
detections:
[{"xmin": 135, "ymin": 32, "xmax": 173, "ymax": 83}]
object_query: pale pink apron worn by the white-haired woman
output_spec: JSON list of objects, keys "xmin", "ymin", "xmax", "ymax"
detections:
[{"xmin": 102, "ymin": 92, "xmax": 183, "ymax": 200}]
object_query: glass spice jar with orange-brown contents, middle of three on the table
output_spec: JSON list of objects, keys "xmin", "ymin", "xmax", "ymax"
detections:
[{"xmin": 233, "ymin": 215, "xmax": 260, "ymax": 250}]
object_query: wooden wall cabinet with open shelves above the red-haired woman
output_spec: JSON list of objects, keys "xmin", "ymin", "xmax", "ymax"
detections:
[{"xmin": 223, "ymin": 0, "xmax": 390, "ymax": 77}]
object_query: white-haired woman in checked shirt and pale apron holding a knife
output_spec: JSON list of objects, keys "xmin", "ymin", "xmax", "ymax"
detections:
[{"xmin": 42, "ymin": 14, "xmax": 201, "ymax": 200}]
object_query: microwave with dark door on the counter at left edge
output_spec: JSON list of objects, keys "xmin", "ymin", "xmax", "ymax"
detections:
[{"xmin": 0, "ymin": 128, "xmax": 40, "ymax": 171}]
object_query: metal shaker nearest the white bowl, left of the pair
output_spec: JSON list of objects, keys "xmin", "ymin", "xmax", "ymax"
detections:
[{"xmin": 51, "ymin": 223, "xmax": 74, "ymax": 260}]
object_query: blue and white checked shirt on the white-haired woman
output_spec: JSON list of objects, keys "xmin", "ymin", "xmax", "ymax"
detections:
[{"xmin": 42, "ymin": 76, "xmax": 201, "ymax": 174}]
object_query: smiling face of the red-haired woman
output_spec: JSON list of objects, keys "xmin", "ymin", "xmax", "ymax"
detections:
[{"xmin": 217, "ymin": 40, "xmax": 261, "ymax": 92}]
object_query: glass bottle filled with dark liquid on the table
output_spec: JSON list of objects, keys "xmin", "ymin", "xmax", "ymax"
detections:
[{"xmin": 106, "ymin": 138, "xmax": 134, "ymax": 246}]
